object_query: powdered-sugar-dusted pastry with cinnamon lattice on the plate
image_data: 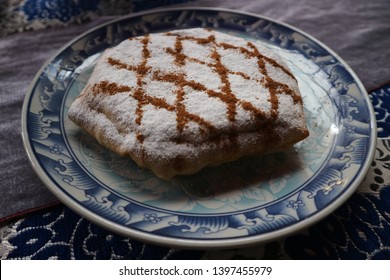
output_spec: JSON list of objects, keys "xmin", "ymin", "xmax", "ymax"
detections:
[{"xmin": 68, "ymin": 28, "xmax": 309, "ymax": 180}]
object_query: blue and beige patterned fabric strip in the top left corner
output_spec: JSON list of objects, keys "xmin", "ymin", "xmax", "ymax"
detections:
[{"xmin": 0, "ymin": 0, "xmax": 191, "ymax": 37}]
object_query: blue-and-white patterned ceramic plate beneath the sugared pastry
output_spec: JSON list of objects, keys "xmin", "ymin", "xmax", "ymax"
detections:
[{"xmin": 22, "ymin": 8, "xmax": 376, "ymax": 248}]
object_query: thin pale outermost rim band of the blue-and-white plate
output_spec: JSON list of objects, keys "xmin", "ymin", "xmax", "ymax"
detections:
[{"xmin": 21, "ymin": 7, "xmax": 377, "ymax": 249}]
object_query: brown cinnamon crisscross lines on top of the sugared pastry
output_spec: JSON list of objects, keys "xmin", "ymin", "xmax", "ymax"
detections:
[{"xmin": 93, "ymin": 31, "xmax": 302, "ymax": 143}]
